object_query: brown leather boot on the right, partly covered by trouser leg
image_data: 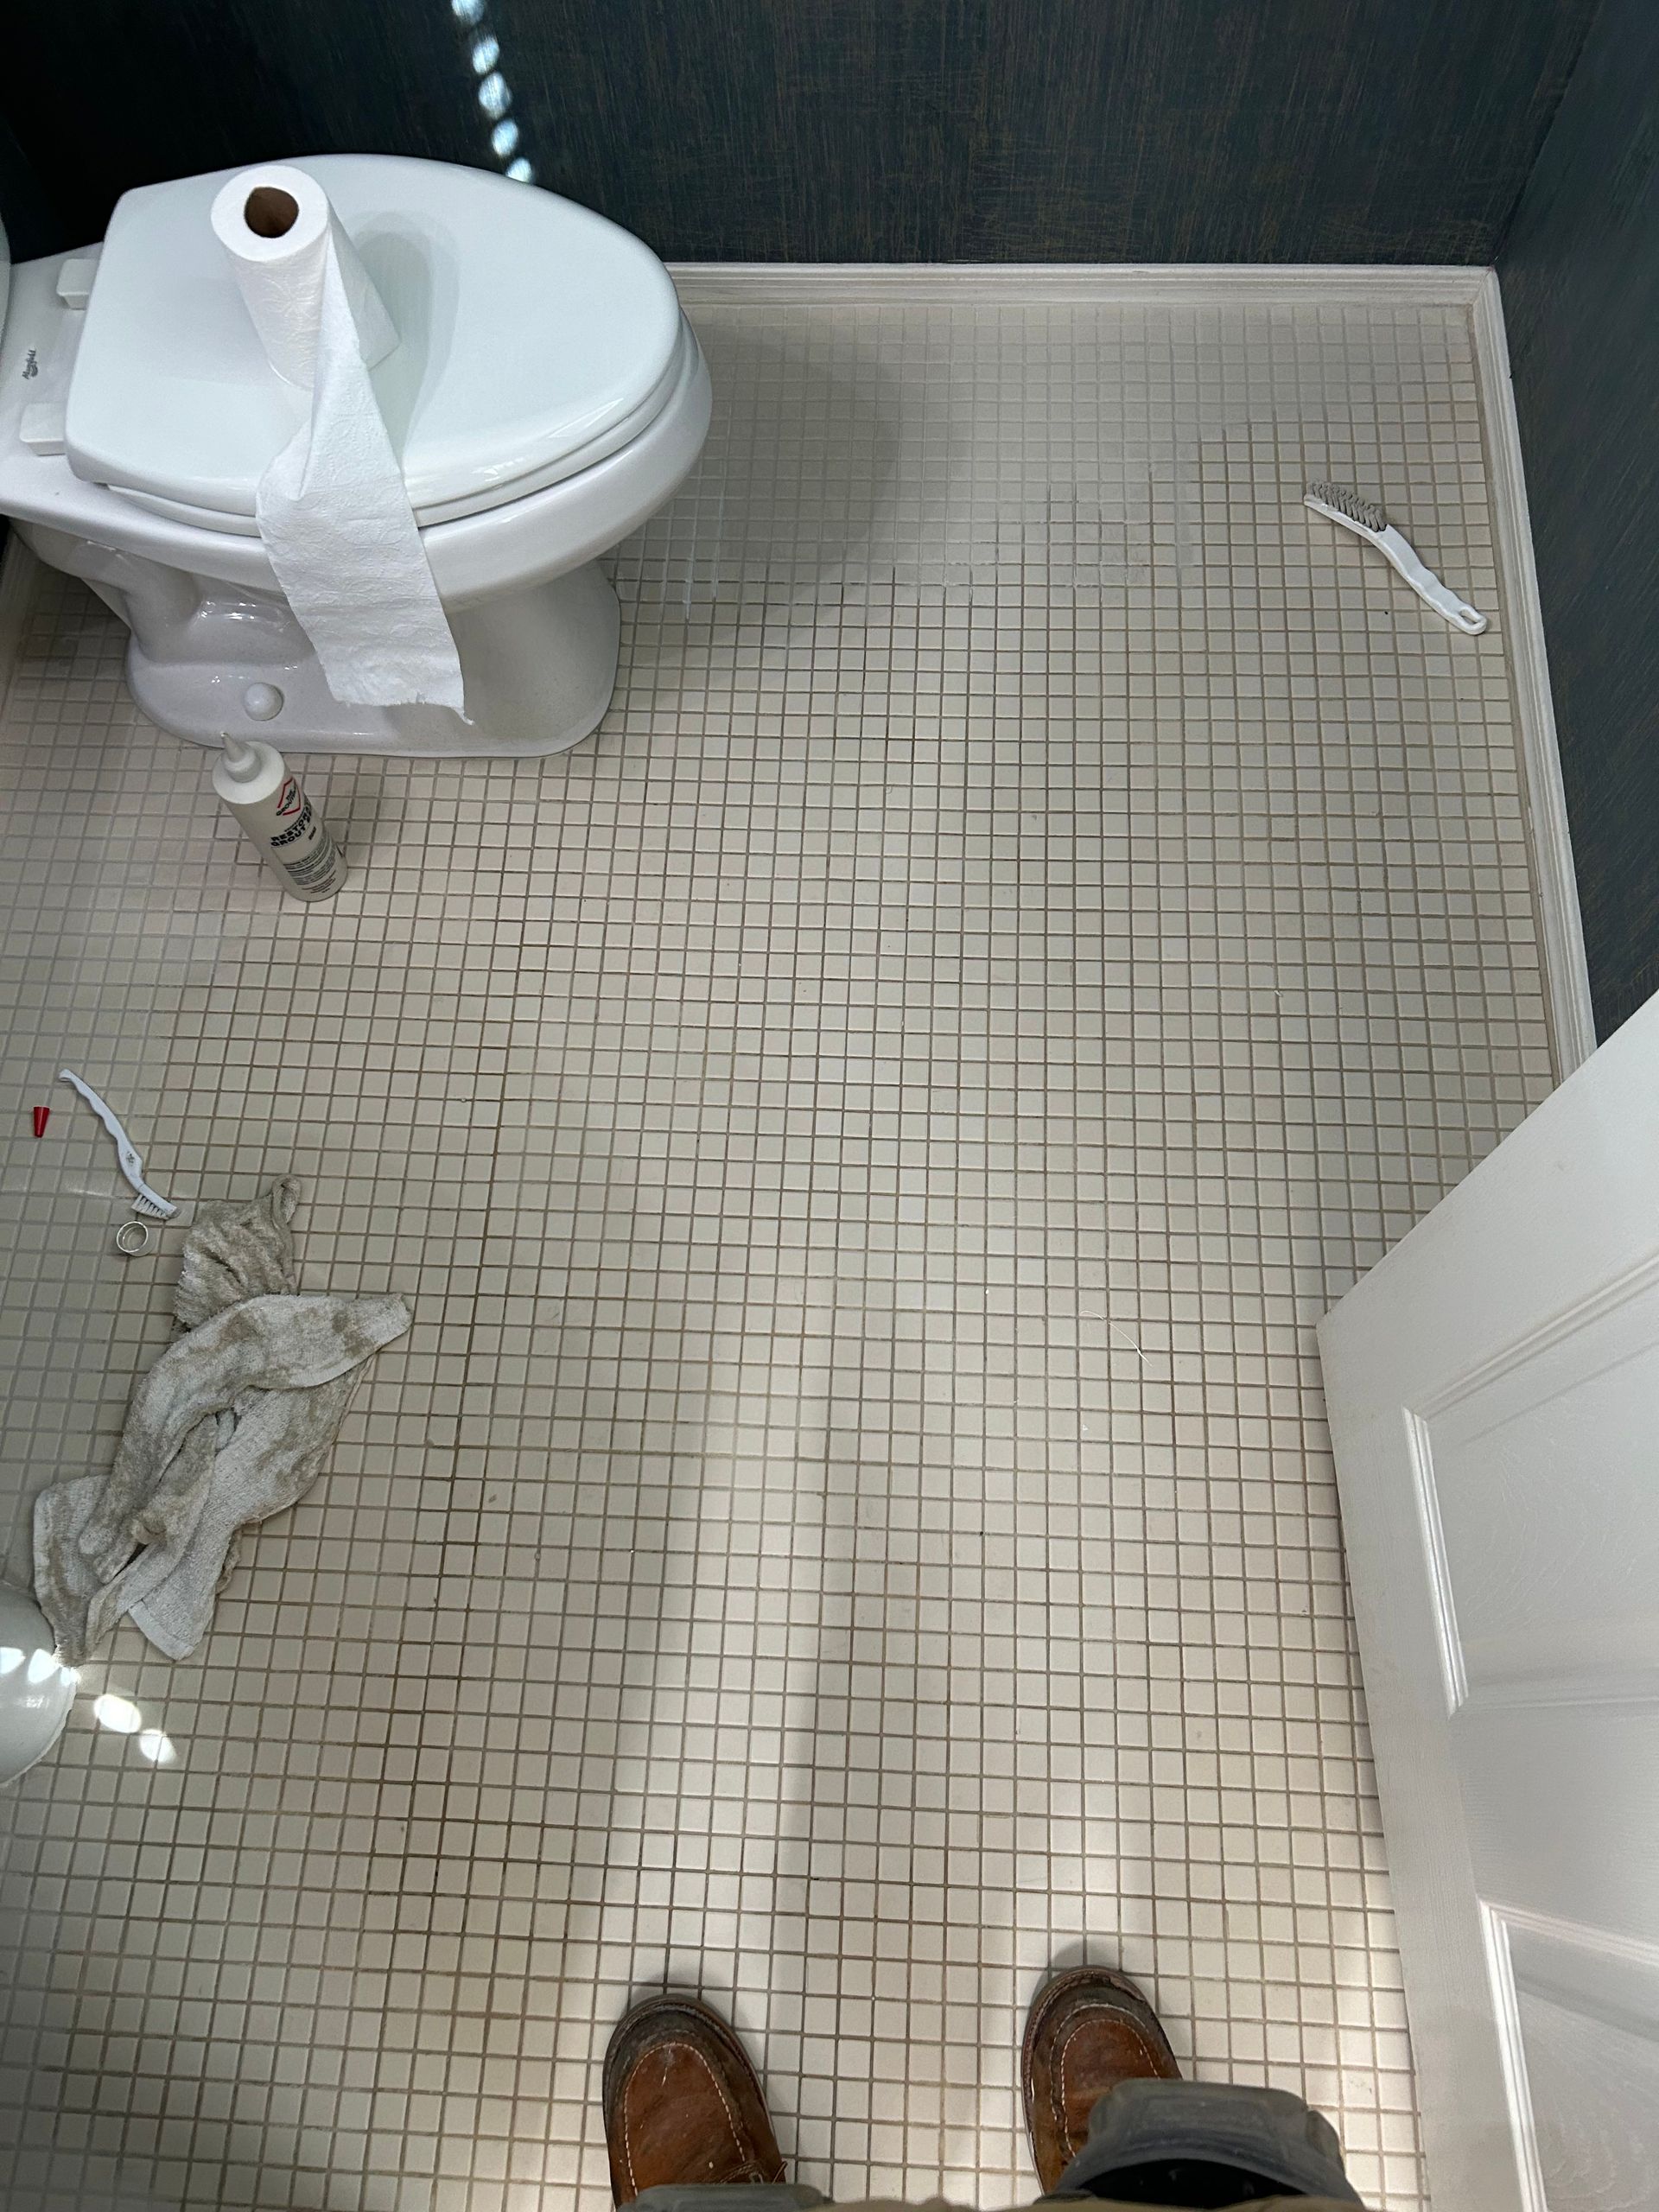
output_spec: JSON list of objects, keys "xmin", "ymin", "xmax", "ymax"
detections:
[{"xmin": 1020, "ymin": 1967, "xmax": 1181, "ymax": 2195}]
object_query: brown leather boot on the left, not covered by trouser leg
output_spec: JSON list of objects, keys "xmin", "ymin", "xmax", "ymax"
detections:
[{"xmin": 604, "ymin": 1993, "xmax": 783, "ymax": 2205}]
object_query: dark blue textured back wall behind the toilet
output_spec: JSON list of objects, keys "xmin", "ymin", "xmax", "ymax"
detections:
[{"xmin": 0, "ymin": 0, "xmax": 1595, "ymax": 261}]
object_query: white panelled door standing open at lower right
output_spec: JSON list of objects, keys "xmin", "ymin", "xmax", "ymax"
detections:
[{"xmin": 1319, "ymin": 1002, "xmax": 1659, "ymax": 2212}]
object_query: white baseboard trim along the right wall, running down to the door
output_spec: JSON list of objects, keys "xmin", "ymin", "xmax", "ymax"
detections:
[{"xmin": 1473, "ymin": 270, "xmax": 1595, "ymax": 1077}]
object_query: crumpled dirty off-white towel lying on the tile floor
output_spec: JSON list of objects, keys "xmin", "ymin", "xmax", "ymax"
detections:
[{"xmin": 35, "ymin": 1179, "xmax": 410, "ymax": 1666}]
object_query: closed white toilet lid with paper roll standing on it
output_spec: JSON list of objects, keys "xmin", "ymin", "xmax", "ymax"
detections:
[{"xmin": 67, "ymin": 155, "xmax": 681, "ymax": 533}]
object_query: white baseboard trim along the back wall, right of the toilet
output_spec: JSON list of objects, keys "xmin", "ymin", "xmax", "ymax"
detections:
[{"xmin": 668, "ymin": 261, "xmax": 1486, "ymax": 308}]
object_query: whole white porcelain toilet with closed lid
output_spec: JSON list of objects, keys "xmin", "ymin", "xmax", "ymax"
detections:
[{"xmin": 0, "ymin": 155, "xmax": 710, "ymax": 757}]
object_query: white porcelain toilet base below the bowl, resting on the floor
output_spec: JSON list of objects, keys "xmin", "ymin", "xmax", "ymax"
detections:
[{"xmin": 104, "ymin": 556, "xmax": 621, "ymax": 761}]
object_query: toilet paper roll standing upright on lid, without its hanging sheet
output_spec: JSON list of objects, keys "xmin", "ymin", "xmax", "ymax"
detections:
[{"xmin": 213, "ymin": 162, "xmax": 398, "ymax": 390}]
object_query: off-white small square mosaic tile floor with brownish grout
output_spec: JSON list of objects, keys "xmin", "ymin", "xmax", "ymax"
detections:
[{"xmin": 0, "ymin": 303, "xmax": 1548, "ymax": 2212}]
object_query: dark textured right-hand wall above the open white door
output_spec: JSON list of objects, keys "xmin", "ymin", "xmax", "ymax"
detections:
[{"xmin": 1497, "ymin": 0, "xmax": 1659, "ymax": 1035}]
